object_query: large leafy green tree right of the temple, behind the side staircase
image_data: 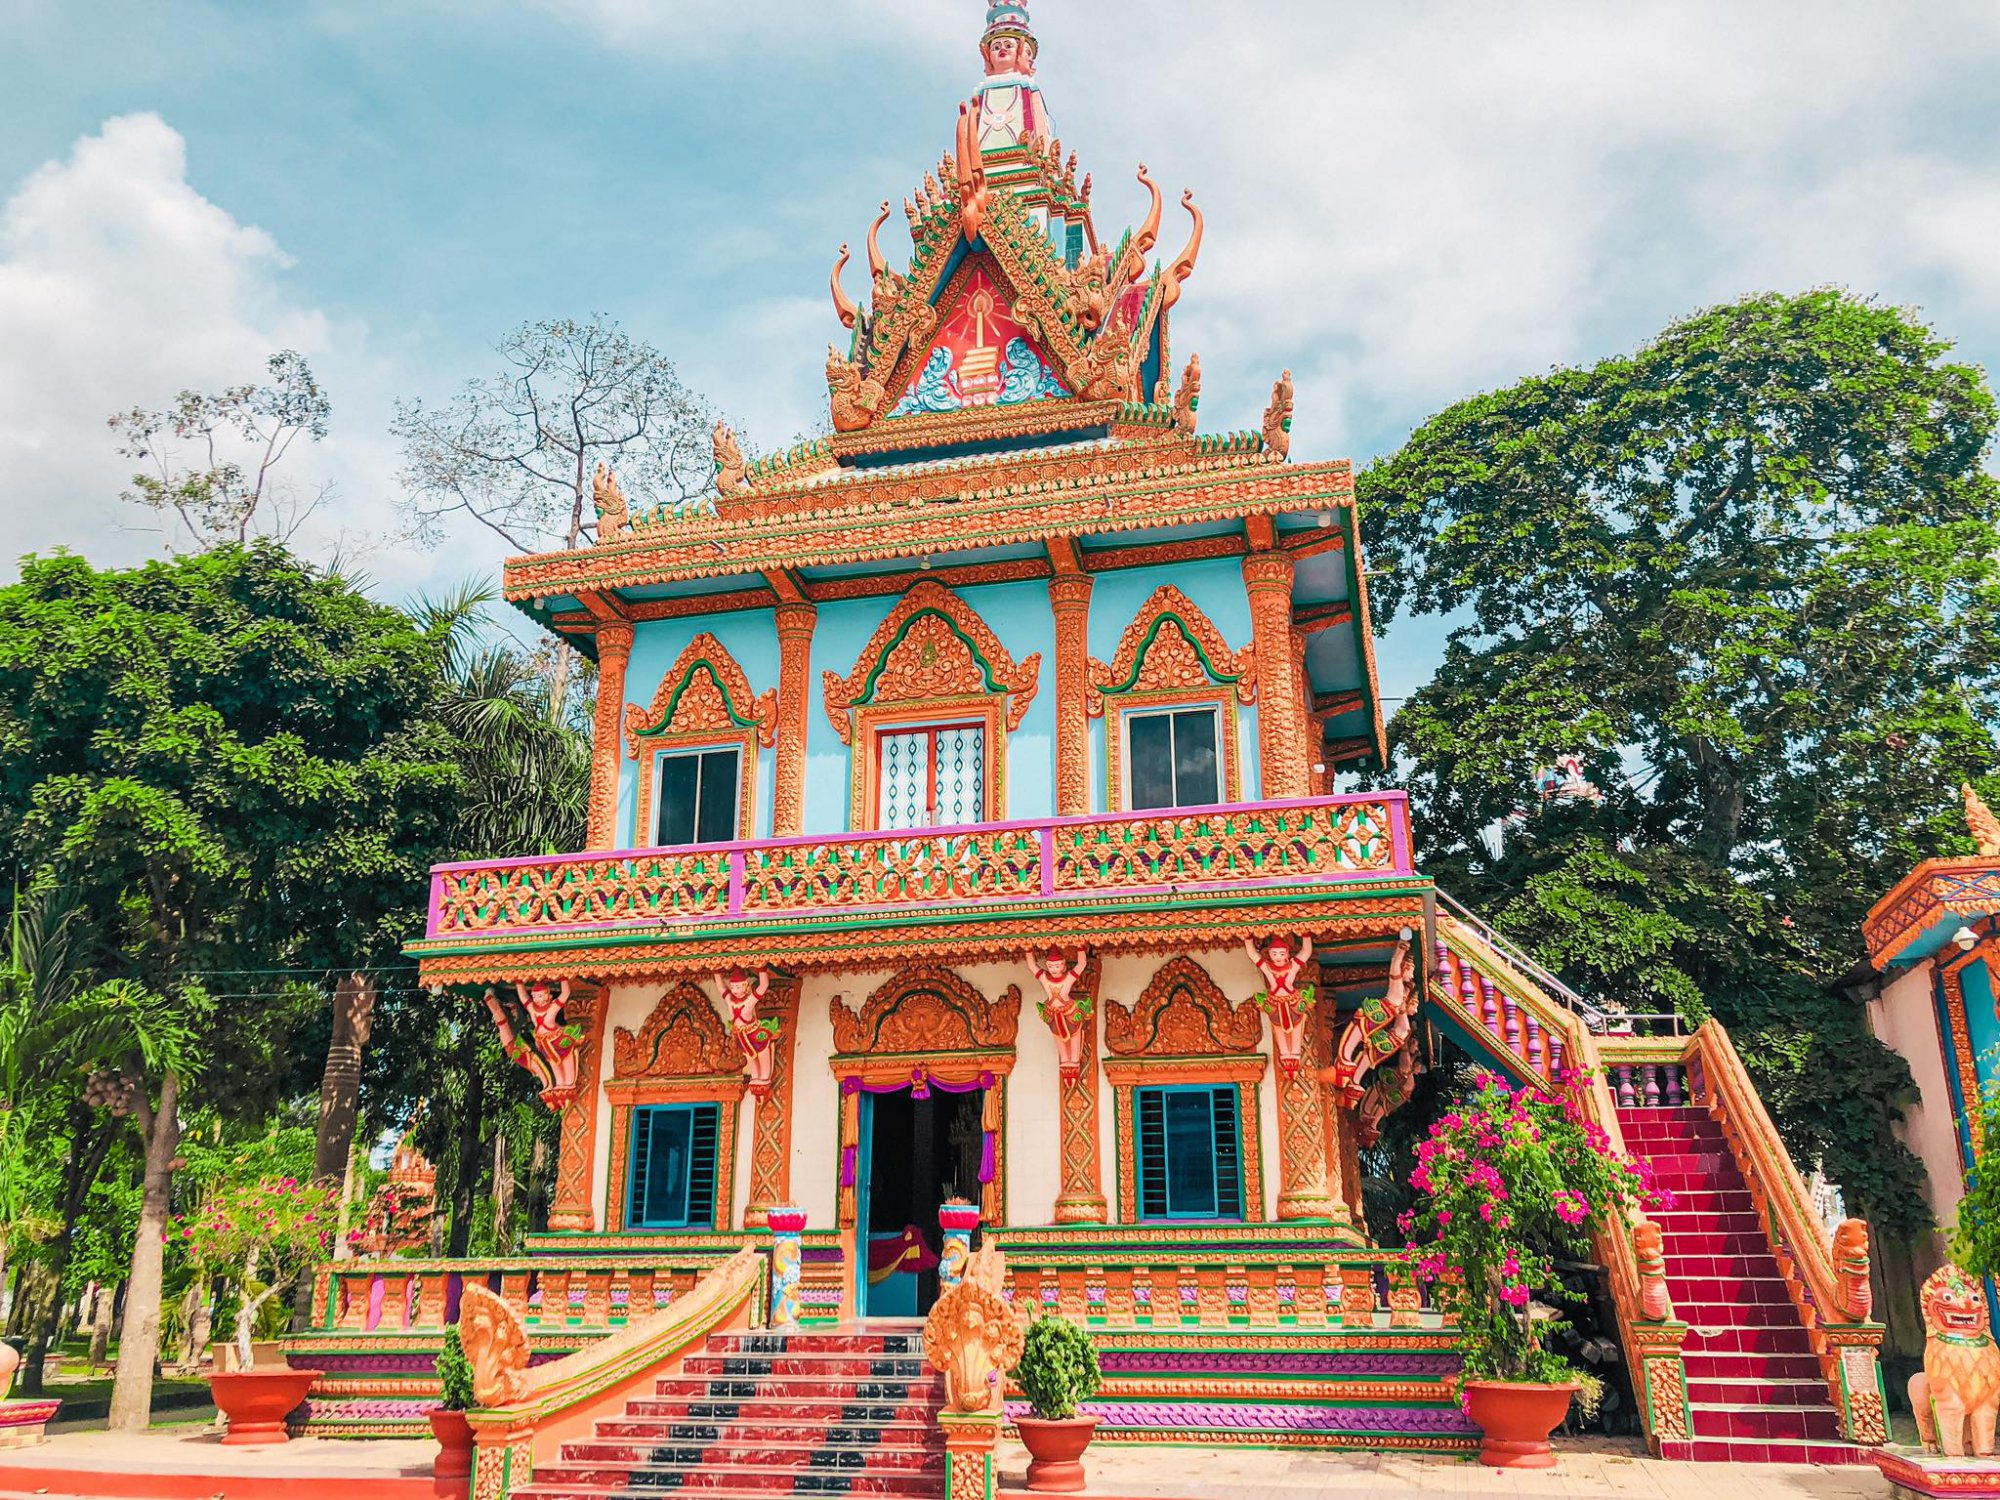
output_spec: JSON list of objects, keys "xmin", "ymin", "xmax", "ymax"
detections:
[{"xmin": 1360, "ymin": 290, "xmax": 2000, "ymax": 1230}]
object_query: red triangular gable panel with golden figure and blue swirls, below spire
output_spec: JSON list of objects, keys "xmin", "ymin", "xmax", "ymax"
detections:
[{"xmin": 890, "ymin": 254, "xmax": 1074, "ymax": 416}]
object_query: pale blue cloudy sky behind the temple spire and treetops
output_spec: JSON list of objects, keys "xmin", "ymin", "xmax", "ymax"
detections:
[{"xmin": 0, "ymin": 0, "xmax": 2000, "ymax": 698}]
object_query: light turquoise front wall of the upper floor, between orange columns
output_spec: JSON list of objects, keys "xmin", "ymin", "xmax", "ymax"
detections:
[{"xmin": 618, "ymin": 558, "xmax": 1264, "ymax": 848}]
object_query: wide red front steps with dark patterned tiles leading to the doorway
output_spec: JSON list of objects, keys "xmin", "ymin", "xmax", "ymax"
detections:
[{"xmin": 514, "ymin": 1328, "xmax": 944, "ymax": 1500}]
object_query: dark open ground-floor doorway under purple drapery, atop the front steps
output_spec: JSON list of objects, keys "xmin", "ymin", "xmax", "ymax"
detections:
[{"xmin": 856, "ymin": 1088, "xmax": 986, "ymax": 1318}]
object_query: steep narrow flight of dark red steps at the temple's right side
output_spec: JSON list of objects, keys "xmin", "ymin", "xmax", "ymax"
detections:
[{"xmin": 1618, "ymin": 1090, "xmax": 1868, "ymax": 1464}]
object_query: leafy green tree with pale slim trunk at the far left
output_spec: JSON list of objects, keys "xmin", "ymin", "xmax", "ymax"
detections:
[{"xmin": 0, "ymin": 542, "xmax": 460, "ymax": 1428}]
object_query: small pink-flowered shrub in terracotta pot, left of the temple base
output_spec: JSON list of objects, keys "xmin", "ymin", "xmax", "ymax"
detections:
[{"xmin": 182, "ymin": 1152, "xmax": 334, "ymax": 1444}]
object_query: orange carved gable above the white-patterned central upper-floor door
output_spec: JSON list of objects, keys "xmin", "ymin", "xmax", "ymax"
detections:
[{"xmin": 824, "ymin": 580, "xmax": 1042, "ymax": 744}]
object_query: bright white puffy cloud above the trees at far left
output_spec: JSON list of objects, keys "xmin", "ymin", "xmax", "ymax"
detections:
[{"xmin": 0, "ymin": 114, "xmax": 432, "ymax": 588}]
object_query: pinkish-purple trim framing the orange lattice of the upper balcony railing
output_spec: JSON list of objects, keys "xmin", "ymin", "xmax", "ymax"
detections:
[{"xmin": 424, "ymin": 792, "xmax": 1414, "ymax": 938}]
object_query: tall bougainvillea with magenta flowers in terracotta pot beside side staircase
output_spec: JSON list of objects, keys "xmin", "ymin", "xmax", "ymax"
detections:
[{"xmin": 1400, "ymin": 1074, "xmax": 1664, "ymax": 1468}]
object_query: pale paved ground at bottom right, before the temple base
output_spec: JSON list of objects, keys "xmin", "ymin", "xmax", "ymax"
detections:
[{"xmin": 1000, "ymin": 1442, "xmax": 1888, "ymax": 1500}]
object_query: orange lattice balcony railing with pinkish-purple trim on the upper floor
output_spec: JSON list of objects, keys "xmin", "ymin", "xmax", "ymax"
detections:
[{"xmin": 426, "ymin": 792, "xmax": 1412, "ymax": 938}]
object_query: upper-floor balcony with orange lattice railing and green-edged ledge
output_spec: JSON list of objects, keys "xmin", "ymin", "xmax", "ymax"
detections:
[{"xmin": 412, "ymin": 792, "xmax": 1414, "ymax": 978}]
